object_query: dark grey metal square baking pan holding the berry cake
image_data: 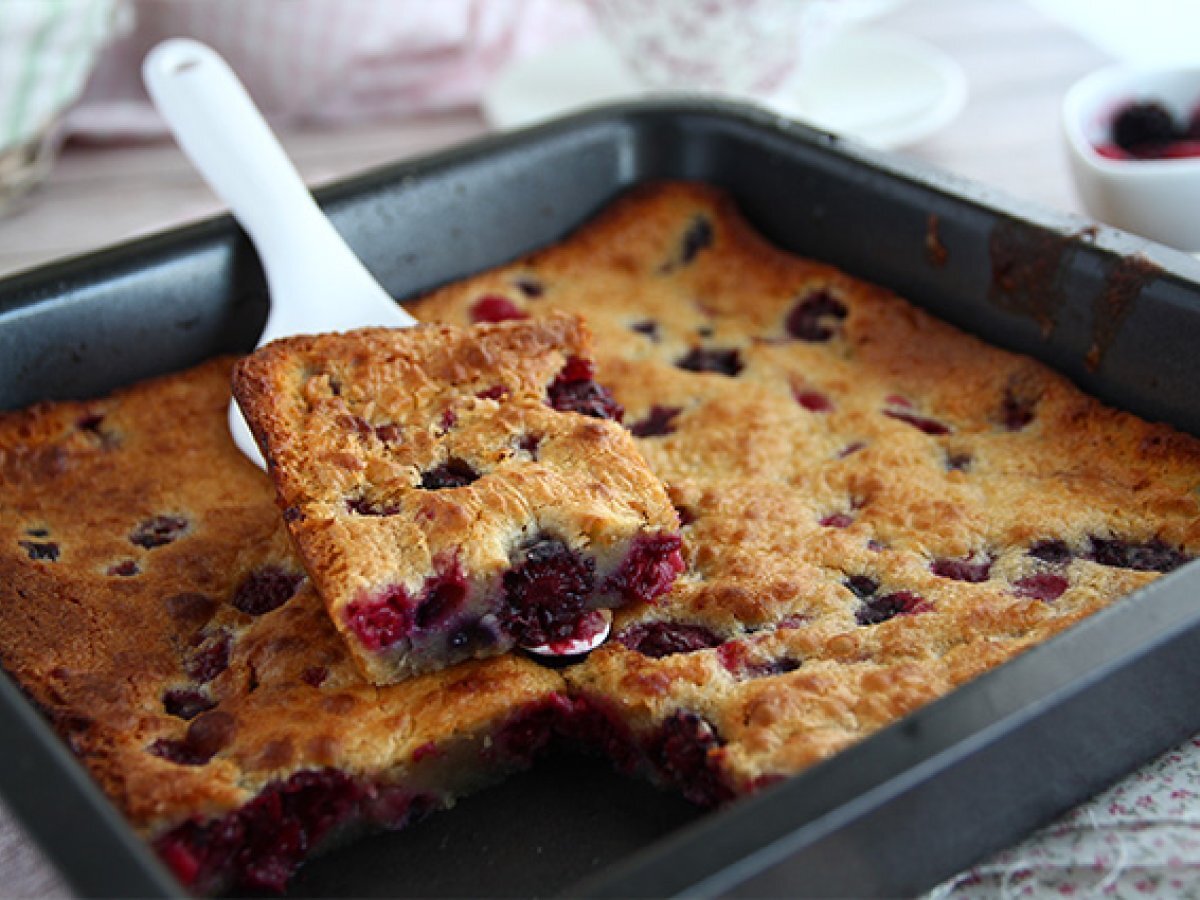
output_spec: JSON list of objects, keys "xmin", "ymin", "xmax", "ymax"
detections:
[{"xmin": 0, "ymin": 101, "xmax": 1200, "ymax": 896}]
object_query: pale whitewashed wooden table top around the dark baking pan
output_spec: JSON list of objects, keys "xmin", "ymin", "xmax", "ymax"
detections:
[{"xmin": 0, "ymin": 0, "xmax": 1132, "ymax": 896}]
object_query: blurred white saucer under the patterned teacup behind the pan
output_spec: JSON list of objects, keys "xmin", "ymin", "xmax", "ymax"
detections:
[{"xmin": 482, "ymin": 31, "xmax": 967, "ymax": 148}]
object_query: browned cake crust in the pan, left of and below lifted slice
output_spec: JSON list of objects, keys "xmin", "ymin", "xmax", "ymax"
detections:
[{"xmin": 0, "ymin": 360, "xmax": 562, "ymax": 835}]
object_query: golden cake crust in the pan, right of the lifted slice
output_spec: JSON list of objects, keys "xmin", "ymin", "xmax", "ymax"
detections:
[{"xmin": 413, "ymin": 184, "xmax": 1200, "ymax": 790}]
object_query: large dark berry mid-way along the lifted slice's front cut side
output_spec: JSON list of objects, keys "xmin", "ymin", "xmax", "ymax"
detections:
[{"xmin": 500, "ymin": 538, "xmax": 595, "ymax": 647}]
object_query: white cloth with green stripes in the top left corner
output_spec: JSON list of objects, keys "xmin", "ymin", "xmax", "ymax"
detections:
[{"xmin": 0, "ymin": 0, "xmax": 121, "ymax": 151}]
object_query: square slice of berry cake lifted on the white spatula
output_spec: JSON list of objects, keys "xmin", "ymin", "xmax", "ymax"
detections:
[{"xmin": 234, "ymin": 314, "xmax": 683, "ymax": 684}]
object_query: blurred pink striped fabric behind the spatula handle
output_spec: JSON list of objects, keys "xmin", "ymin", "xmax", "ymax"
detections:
[{"xmin": 67, "ymin": 0, "xmax": 590, "ymax": 140}]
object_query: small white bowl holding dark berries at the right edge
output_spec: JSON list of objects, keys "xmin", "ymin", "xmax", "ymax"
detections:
[{"xmin": 1062, "ymin": 65, "xmax": 1200, "ymax": 252}]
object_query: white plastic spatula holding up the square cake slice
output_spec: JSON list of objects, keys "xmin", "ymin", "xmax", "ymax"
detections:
[{"xmin": 142, "ymin": 38, "xmax": 416, "ymax": 468}]
